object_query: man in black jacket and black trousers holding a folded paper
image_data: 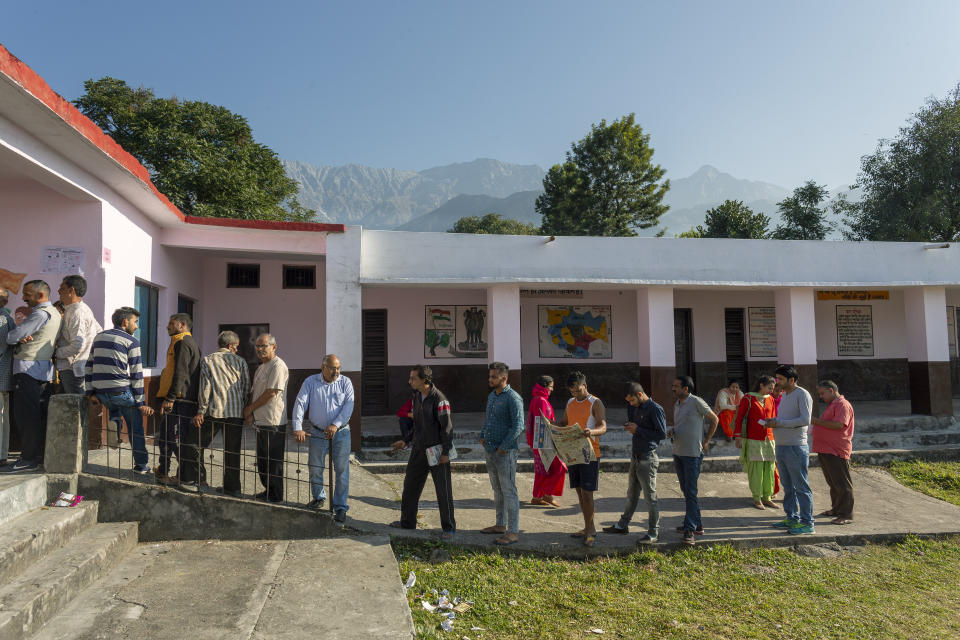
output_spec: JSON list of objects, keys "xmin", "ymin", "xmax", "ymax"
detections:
[{"xmin": 390, "ymin": 364, "xmax": 457, "ymax": 540}]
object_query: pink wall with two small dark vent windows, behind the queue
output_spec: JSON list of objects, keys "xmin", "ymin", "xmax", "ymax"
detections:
[{"xmin": 198, "ymin": 250, "xmax": 326, "ymax": 371}]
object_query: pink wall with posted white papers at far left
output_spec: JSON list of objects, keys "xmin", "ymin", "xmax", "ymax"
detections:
[{"xmin": 0, "ymin": 178, "xmax": 103, "ymax": 322}]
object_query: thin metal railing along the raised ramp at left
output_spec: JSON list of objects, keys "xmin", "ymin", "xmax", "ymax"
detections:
[{"xmin": 84, "ymin": 407, "xmax": 338, "ymax": 512}]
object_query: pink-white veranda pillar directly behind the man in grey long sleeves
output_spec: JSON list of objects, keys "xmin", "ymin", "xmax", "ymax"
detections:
[{"xmin": 774, "ymin": 287, "xmax": 818, "ymax": 398}]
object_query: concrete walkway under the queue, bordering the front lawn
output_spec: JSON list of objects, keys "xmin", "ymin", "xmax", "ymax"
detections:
[{"xmin": 347, "ymin": 466, "xmax": 960, "ymax": 556}]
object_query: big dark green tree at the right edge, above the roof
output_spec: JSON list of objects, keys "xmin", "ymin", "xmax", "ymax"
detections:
[{"xmin": 836, "ymin": 84, "xmax": 960, "ymax": 242}]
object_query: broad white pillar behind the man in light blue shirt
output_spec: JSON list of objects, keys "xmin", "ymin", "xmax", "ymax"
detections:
[{"xmin": 324, "ymin": 227, "xmax": 363, "ymax": 451}]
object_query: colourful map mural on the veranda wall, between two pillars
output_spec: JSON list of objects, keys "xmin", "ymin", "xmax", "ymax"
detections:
[{"xmin": 537, "ymin": 305, "xmax": 613, "ymax": 359}]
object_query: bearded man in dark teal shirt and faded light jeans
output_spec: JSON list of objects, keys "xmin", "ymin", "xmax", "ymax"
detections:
[{"xmin": 480, "ymin": 362, "xmax": 524, "ymax": 545}]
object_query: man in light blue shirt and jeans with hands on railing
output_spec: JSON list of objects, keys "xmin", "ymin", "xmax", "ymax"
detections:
[{"xmin": 292, "ymin": 353, "xmax": 353, "ymax": 522}]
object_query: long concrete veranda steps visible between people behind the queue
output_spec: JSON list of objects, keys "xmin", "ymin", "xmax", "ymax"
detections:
[{"xmin": 360, "ymin": 409, "xmax": 960, "ymax": 472}]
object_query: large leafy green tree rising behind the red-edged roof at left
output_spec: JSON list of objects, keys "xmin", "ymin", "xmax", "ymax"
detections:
[{"xmin": 74, "ymin": 77, "xmax": 314, "ymax": 220}]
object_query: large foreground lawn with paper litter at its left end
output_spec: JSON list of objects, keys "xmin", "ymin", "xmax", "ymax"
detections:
[{"xmin": 394, "ymin": 538, "xmax": 960, "ymax": 640}]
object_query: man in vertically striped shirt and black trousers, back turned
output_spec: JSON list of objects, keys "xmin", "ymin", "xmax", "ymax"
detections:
[{"xmin": 180, "ymin": 331, "xmax": 250, "ymax": 498}]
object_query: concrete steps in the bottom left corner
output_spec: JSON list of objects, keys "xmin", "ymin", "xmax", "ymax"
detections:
[{"xmin": 0, "ymin": 475, "xmax": 137, "ymax": 640}]
